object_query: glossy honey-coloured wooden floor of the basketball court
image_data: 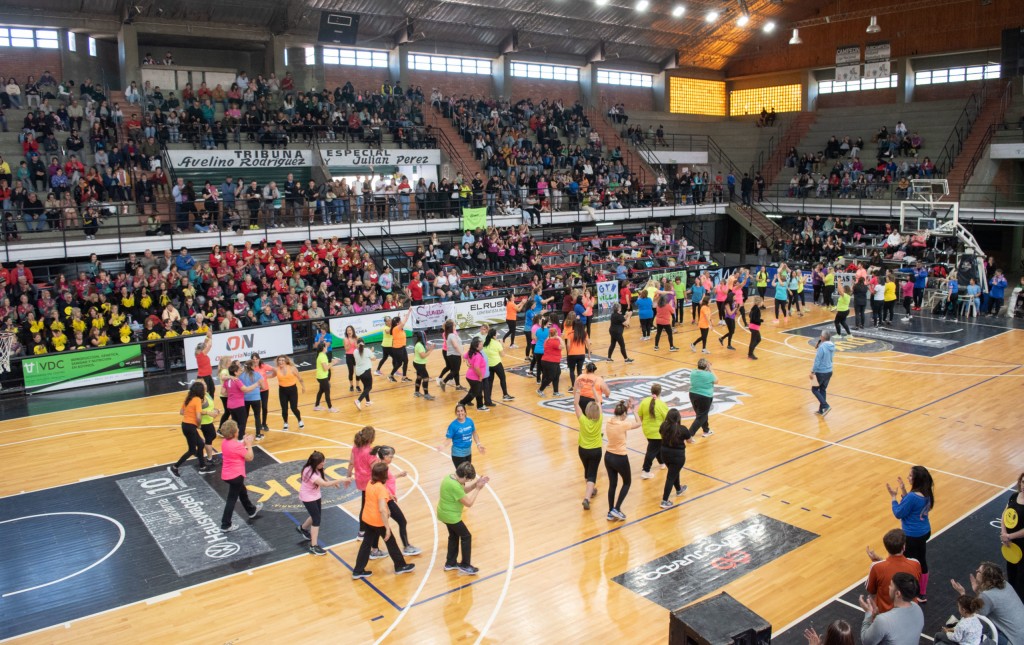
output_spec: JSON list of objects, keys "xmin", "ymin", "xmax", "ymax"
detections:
[{"xmin": 0, "ymin": 308, "xmax": 1024, "ymax": 643}]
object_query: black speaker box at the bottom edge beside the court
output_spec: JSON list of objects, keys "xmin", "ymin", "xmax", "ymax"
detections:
[{"xmin": 669, "ymin": 592, "xmax": 771, "ymax": 645}]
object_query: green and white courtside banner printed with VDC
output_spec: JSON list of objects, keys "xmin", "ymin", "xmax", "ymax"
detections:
[{"xmin": 22, "ymin": 345, "xmax": 142, "ymax": 392}]
